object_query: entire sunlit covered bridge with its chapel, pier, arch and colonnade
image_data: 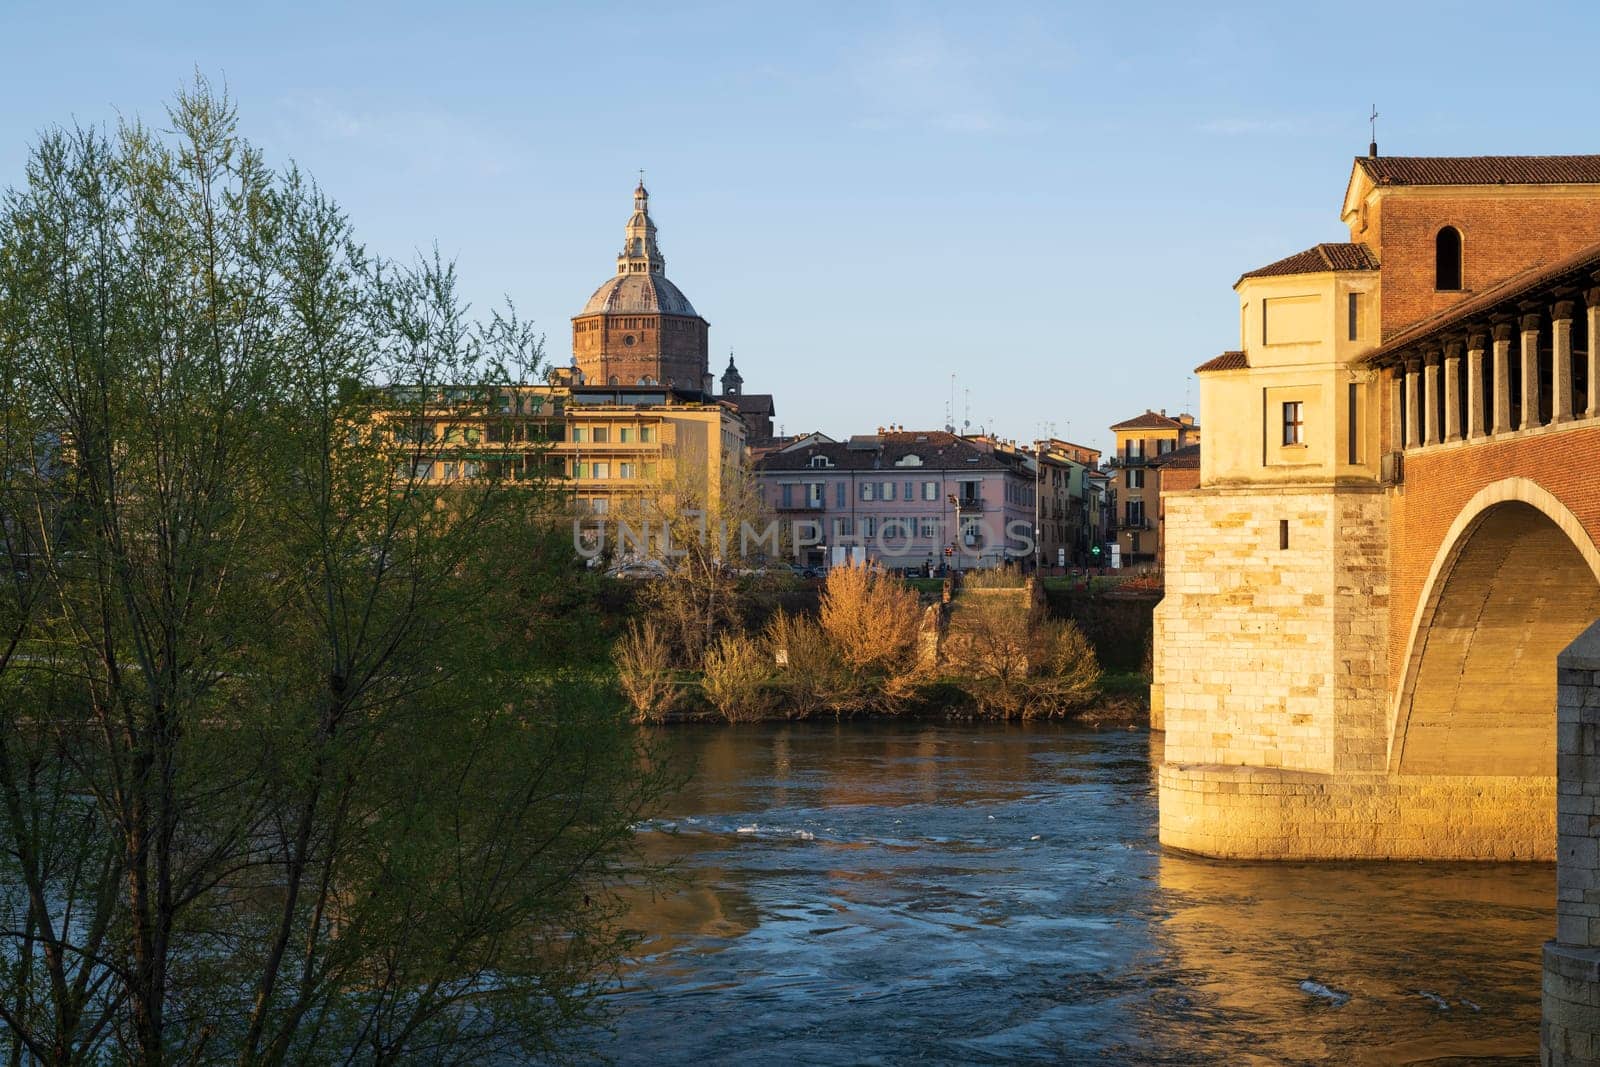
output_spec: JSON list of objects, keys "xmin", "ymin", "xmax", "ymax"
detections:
[{"xmin": 1152, "ymin": 146, "xmax": 1600, "ymax": 859}]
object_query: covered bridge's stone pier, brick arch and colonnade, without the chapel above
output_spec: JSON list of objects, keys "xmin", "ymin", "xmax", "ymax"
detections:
[{"xmin": 1155, "ymin": 267, "xmax": 1600, "ymax": 861}]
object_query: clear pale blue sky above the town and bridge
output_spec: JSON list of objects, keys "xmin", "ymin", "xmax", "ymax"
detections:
[{"xmin": 0, "ymin": 0, "xmax": 1600, "ymax": 445}]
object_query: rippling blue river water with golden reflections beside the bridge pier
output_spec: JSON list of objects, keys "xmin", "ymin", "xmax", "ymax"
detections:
[{"xmin": 603, "ymin": 723, "xmax": 1555, "ymax": 1067}]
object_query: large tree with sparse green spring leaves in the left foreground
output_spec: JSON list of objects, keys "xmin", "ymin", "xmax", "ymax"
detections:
[{"xmin": 0, "ymin": 82, "xmax": 667, "ymax": 1064}]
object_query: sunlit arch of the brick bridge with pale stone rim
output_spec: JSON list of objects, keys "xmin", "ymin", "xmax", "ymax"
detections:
[{"xmin": 1389, "ymin": 478, "xmax": 1600, "ymax": 779}]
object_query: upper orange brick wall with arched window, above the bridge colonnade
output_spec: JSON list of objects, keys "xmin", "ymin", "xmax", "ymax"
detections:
[{"xmin": 1360, "ymin": 192, "xmax": 1600, "ymax": 338}]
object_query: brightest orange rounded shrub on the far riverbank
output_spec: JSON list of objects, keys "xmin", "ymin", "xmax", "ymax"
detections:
[{"xmin": 822, "ymin": 566, "xmax": 922, "ymax": 673}]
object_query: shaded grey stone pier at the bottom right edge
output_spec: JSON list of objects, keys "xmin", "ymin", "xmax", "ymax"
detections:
[{"xmin": 1539, "ymin": 622, "xmax": 1600, "ymax": 1067}]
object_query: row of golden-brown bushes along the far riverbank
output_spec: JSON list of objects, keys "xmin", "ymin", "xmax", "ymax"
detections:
[{"xmin": 611, "ymin": 566, "xmax": 1149, "ymax": 725}]
